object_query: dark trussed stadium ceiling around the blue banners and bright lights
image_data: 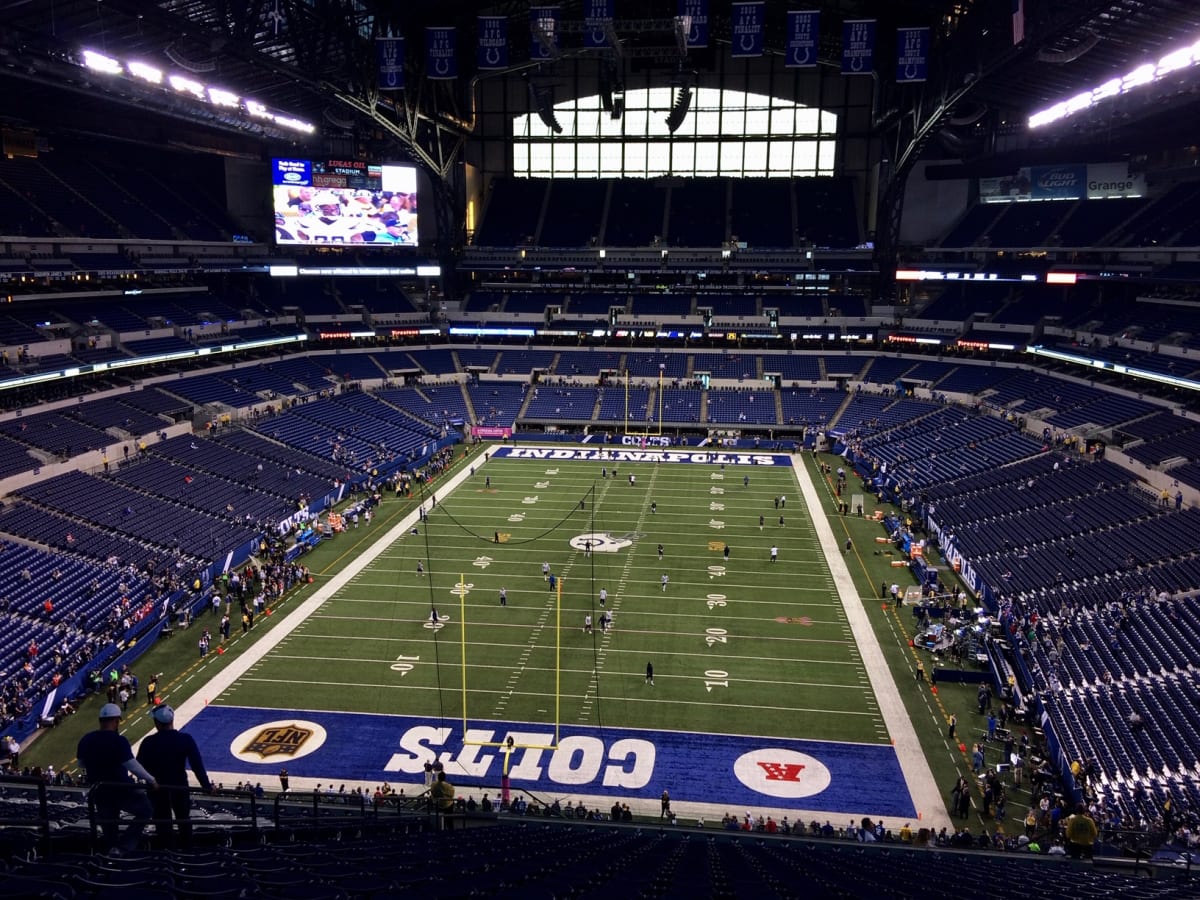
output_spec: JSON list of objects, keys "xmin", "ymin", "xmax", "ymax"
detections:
[{"xmin": 0, "ymin": 0, "xmax": 1200, "ymax": 164}]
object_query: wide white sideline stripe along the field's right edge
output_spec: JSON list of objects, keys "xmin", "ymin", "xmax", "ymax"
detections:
[{"xmin": 792, "ymin": 455, "xmax": 953, "ymax": 829}]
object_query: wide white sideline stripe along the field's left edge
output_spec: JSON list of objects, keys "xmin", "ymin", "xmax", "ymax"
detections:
[{"xmin": 159, "ymin": 451, "xmax": 487, "ymax": 727}]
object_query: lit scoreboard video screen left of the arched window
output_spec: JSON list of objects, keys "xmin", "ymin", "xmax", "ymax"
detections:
[{"xmin": 271, "ymin": 160, "xmax": 420, "ymax": 247}]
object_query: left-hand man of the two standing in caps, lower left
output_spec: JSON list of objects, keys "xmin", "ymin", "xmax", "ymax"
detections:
[{"xmin": 76, "ymin": 703, "xmax": 158, "ymax": 853}]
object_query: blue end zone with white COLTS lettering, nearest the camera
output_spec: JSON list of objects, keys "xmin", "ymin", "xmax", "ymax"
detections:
[{"xmin": 186, "ymin": 706, "xmax": 917, "ymax": 818}]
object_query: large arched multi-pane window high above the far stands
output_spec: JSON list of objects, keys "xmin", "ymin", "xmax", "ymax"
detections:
[{"xmin": 512, "ymin": 88, "xmax": 838, "ymax": 178}]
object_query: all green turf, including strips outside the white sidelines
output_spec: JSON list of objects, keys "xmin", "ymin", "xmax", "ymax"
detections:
[{"xmin": 22, "ymin": 454, "xmax": 1028, "ymax": 827}]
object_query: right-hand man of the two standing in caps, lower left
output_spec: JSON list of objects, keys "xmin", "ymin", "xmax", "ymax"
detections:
[{"xmin": 138, "ymin": 703, "xmax": 212, "ymax": 848}]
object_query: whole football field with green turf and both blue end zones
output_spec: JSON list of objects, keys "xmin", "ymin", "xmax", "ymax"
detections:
[{"xmin": 180, "ymin": 448, "xmax": 913, "ymax": 816}]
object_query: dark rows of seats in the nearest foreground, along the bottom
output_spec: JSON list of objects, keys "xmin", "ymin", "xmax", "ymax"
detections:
[{"xmin": 6, "ymin": 816, "xmax": 1195, "ymax": 900}]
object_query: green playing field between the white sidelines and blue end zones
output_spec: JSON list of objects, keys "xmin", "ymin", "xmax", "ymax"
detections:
[{"xmin": 216, "ymin": 458, "xmax": 888, "ymax": 742}]
